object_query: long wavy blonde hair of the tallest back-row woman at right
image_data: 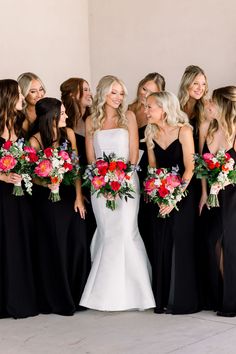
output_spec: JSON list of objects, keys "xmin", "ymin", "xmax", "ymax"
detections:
[{"xmin": 178, "ymin": 65, "xmax": 208, "ymax": 128}]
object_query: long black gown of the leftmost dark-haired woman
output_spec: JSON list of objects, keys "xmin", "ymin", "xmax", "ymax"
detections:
[{"xmin": 0, "ymin": 137, "xmax": 38, "ymax": 318}]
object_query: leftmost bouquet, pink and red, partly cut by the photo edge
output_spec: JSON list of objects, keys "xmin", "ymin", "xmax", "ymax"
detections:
[{"xmin": 0, "ymin": 139, "xmax": 38, "ymax": 196}]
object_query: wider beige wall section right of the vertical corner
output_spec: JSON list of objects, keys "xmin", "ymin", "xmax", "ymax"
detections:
[{"xmin": 89, "ymin": 0, "xmax": 236, "ymax": 101}]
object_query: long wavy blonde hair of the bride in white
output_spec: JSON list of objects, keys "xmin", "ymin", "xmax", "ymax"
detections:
[{"xmin": 91, "ymin": 75, "xmax": 128, "ymax": 133}]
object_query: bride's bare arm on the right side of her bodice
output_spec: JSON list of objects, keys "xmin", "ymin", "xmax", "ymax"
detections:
[{"xmin": 126, "ymin": 111, "xmax": 139, "ymax": 165}]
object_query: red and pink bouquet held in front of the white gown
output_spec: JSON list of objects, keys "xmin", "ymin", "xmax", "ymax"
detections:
[{"xmin": 83, "ymin": 153, "xmax": 137, "ymax": 210}]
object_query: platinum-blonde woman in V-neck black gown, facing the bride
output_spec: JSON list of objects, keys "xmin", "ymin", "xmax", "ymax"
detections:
[{"xmin": 145, "ymin": 92, "xmax": 198, "ymax": 314}]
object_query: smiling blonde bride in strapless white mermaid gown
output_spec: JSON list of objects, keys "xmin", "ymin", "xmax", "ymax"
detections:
[{"xmin": 80, "ymin": 75, "xmax": 155, "ymax": 311}]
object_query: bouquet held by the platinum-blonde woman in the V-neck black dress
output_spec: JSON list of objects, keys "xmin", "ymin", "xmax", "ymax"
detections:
[{"xmin": 144, "ymin": 166, "xmax": 187, "ymax": 218}]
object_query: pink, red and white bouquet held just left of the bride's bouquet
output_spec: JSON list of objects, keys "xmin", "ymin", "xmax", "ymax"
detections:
[{"xmin": 34, "ymin": 146, "xmax": 79, "ymax": 202}]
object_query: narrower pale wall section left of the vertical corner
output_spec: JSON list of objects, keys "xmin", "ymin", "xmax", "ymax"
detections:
[{"xmin": 0, "ymin": 0, "xmax": 90, "ymax": 97}]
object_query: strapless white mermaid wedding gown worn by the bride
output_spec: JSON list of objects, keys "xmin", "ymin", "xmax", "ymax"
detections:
[{"xmin": 80, "ymin": 128, "xmax": 155, "ymax": 311}]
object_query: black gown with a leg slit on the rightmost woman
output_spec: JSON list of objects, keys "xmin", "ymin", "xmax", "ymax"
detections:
[{"xmin": 203, "ymin": 143, "xmax": 236, "ymax": 316}]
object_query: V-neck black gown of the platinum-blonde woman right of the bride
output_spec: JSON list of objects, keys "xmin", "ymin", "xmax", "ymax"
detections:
[{"xmin": 150, "ymin": 134, "xmax": 198, "ymax": 314}]
